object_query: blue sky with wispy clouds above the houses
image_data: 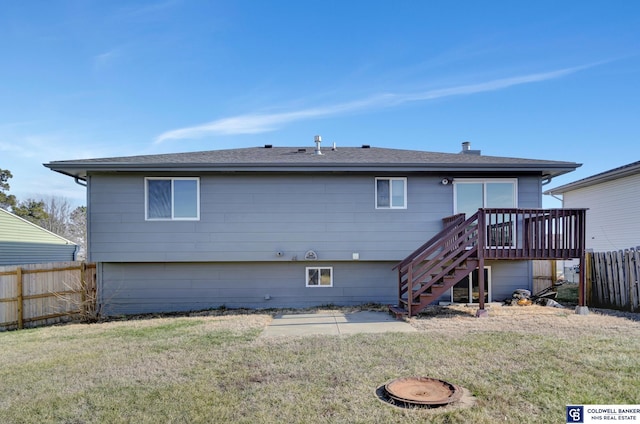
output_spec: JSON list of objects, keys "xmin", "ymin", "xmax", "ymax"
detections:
[{"xmin": 0, "ymin": 0, "xmax": 640, "ymax": 207}]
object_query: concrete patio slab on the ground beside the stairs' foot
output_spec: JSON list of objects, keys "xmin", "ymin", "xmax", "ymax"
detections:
[{"xmin": 263, "ymin": 311, "xmax": 416, "ymax": 337}]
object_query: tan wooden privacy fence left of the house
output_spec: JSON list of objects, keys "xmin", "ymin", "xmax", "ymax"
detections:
[{"xmin": 0, "ymin": 262, "xmax": 96, "ymax": 331}]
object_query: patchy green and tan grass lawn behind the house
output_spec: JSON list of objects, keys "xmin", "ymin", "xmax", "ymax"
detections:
[{"xmin": 0, "ymin": 307, "xmax": 640, "ymax": 424}]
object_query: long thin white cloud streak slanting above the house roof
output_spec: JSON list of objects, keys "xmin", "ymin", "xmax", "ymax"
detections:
[{"xmin": 155, "ymin": 64, "xmax": 595, "ymax": 144}]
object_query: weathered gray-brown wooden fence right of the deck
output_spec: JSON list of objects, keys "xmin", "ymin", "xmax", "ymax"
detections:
[{"xmin": 587, "ymin": 247, "xmax": 640, "ymax": 312}]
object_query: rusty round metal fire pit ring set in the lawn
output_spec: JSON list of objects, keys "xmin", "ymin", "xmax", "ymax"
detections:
[{"xmin": 384, "ymin": 377, "xmax": 462, "ymax": 407}]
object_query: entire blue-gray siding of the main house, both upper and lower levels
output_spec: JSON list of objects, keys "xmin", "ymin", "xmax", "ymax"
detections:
[{"xmin": 88, "ymin": 174, "xmax": 541, "ymax": 315}]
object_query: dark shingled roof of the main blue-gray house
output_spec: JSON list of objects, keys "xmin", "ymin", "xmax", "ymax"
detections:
[{"xmin": 44, "ymin": 145, "xmax": 581, "ymax": 179}]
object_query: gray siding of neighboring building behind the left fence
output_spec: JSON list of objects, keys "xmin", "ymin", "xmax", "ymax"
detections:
[{"xmin": 0, "ymin": 241, "xmax": 77, "ymax": 265}]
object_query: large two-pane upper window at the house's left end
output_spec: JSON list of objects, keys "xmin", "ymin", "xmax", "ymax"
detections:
[{"xmin": 145, "ymin": 177, "xmax": 200, "ymax": 220}]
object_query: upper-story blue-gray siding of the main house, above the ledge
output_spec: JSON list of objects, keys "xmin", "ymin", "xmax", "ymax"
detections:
[{"xmin": 89, "ymin": 174, "xmax": 541, "ymax": 262}]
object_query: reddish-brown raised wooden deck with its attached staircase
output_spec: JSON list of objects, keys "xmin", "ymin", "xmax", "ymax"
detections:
[{"xmin": 394, "ymin": 208, "xmax": 586, "ymax": 316}]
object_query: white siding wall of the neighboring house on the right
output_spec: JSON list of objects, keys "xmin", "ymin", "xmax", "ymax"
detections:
[{"xmin": 563, "ymin": 174, "xmax": 640, "ymax": 252}]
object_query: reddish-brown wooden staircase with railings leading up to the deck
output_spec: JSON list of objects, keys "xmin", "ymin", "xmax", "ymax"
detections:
[{"xmin": 389, "ymin": 213, "xmax": 479, "ymax": 317}]
